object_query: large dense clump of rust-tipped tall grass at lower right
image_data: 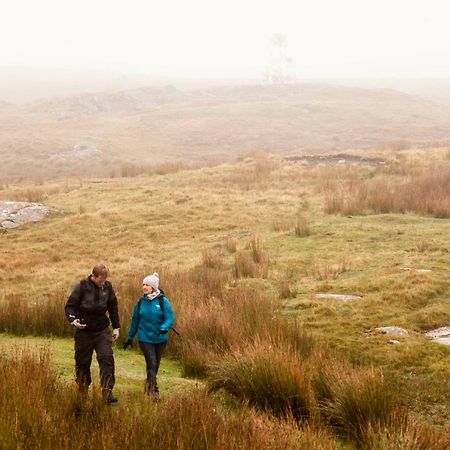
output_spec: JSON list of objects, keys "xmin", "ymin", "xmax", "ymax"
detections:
[{"xmin": 208, "ymin": 340, "xmax": 448, "ymax": 449}]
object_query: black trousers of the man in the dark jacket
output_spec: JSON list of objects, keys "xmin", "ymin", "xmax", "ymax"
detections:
[{"xmin": 75, "ymin": 328, "xmax": 115, "ymax": 389}]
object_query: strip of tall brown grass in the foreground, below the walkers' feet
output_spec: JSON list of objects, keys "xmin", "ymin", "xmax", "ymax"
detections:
[{"xmin": 0, "ymin": 349, "xmax": 337, "ymax": 449}]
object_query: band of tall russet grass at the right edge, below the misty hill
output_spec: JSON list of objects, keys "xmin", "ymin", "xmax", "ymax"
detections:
[{"xmin": 325, "ymin": 168, "xmax": 450, "ymax": 218}]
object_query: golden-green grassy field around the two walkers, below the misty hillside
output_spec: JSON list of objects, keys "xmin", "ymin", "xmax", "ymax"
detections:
[{"xmin": 0, "ymin": 147, "xmax": 450, "ymax": 449}]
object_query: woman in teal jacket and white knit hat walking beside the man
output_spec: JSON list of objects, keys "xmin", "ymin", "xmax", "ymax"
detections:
[{"xmin": 123, "ymin": 272, "xmax": 175, "ymax": 401}]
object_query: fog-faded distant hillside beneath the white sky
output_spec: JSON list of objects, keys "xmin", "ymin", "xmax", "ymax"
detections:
[{"xmin": 0, "ymin": 84, "xmax": 450, "ymax": 176}]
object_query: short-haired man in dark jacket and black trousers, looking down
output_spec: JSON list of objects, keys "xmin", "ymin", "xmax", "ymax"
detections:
[{"xmin": 65, "ymin": 264, "xmax": 120, "ymax": 403}]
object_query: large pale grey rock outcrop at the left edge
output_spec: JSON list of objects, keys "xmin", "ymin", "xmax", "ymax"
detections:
[{"xmin": 0, "ymin": 201, "xmax": 51, "ymax": 229}]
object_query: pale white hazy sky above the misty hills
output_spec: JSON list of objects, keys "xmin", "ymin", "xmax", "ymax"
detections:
[{"xmin": 0, "ymin": 0, "xmax": 450, "ymax": 78}]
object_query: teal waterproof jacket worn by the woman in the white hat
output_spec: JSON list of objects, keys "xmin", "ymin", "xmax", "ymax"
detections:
[{"xmin": 128, "ymin": 292, "xmax": 175, "ymax": 344}]
